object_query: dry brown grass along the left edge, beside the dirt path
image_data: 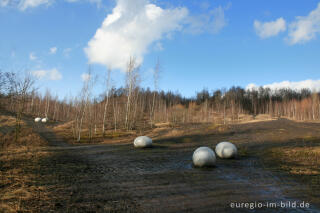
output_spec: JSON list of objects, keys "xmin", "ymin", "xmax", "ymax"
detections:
[{"xmin": 0, "ymin": 116, "xmax": 48, "ymax": 212}]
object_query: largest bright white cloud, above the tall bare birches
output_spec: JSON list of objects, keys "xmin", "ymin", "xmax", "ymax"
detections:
[{"xmin": 84, "ymin": 0, "xmax": 188, "ymax": 71}]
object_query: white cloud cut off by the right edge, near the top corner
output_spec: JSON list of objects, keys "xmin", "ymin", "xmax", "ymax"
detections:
[{"xmin": 287, "ymin": 3, "xmax": 320, "ymax": 44}]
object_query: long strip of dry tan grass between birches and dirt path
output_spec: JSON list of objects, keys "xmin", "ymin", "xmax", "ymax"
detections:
[{"xmin": 53, "ymin": 114, "xmax": 275, "ymax": 143}]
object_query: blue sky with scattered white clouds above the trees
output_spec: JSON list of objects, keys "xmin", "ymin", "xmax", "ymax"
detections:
[{"xmin": 0, "ymin": 0, "xmax": 320, "ymax": 97}]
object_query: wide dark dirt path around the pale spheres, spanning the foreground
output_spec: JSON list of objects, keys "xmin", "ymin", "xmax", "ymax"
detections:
[{"xmin": 21, "ymin": 120, "xmax": 320, "ymax": 212}]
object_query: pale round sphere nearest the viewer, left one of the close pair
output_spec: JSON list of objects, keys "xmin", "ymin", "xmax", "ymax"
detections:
[{"xmin": 192, "ymin": 146, "xmax": 216, "ymax": 167}]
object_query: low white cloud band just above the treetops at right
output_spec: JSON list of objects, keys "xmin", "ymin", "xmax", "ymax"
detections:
[{"xmin": 246, "ymin": 80, "xmax": 320, "ymax": 92}]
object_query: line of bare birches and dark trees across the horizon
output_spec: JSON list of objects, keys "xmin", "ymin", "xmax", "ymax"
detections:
[{"xmin": 0, "ymin": 62, "xmax": 320, "ymax": 141}]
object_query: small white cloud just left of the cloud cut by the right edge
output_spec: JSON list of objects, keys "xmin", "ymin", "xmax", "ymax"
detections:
[{"xmin": 253, "ymin": 17, "xmax": 286, "ymax": 39}]
